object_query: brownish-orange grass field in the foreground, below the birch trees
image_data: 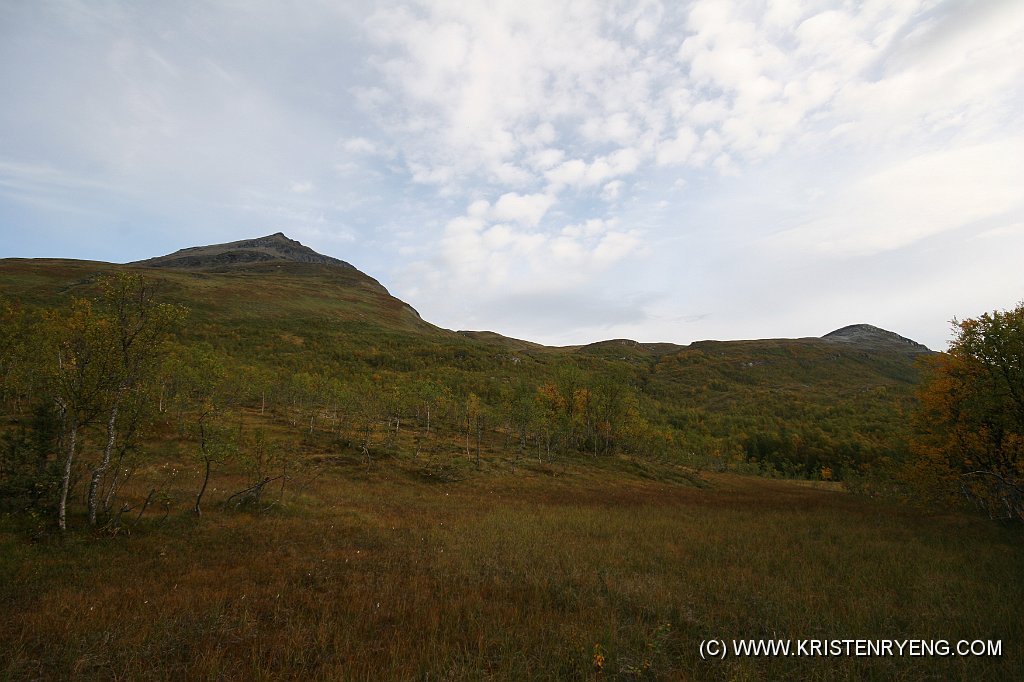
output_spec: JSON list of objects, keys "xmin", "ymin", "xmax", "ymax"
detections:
[{"xmin": 0, "ymin": 459, "xmax": 1024, "ymax": 680}]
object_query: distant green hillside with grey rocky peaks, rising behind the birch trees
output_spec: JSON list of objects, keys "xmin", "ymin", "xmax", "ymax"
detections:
[{"xmin": 0, "ymin": 233, "xmax": 930, "ymax": 476}]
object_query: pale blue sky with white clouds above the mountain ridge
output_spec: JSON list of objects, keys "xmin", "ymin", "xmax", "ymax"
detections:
[{"xmin": 0, "ymin": 0, "xmax": 1024, "ymax": 349}]
